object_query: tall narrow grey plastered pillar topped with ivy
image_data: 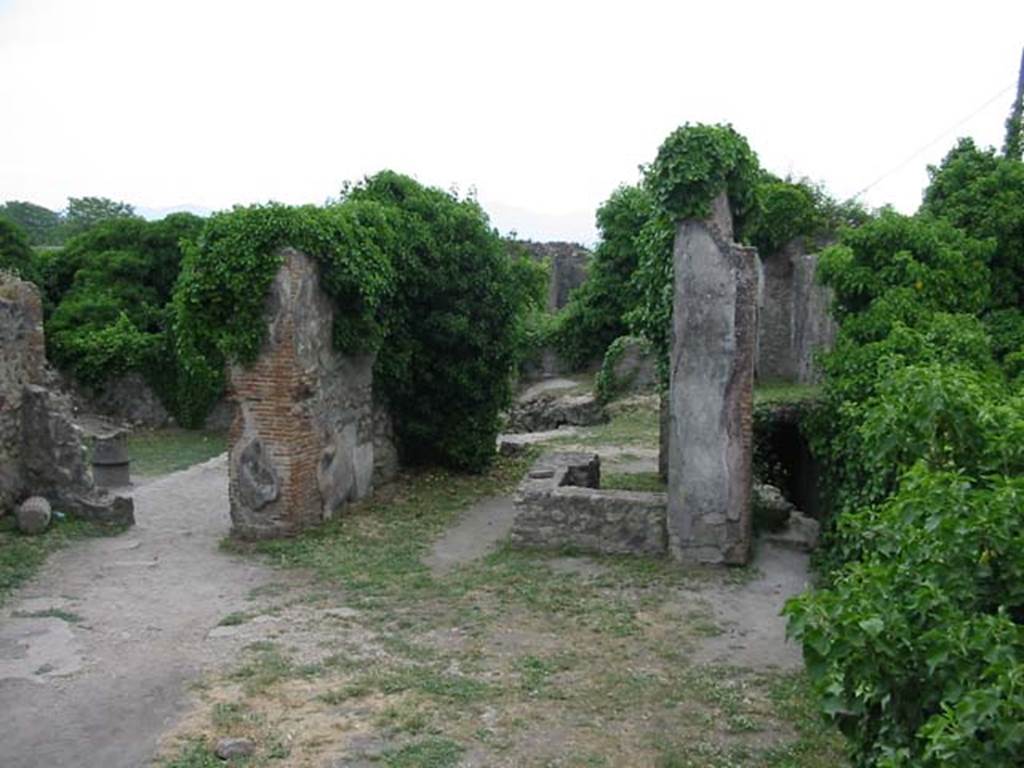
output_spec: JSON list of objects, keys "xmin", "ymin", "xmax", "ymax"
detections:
[{"xmin": 669, "ymin": 194, "xmax": 759, "ymax": 565}]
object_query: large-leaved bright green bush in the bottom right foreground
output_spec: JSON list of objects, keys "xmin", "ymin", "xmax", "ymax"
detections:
[{"xmin": 786, "ymin": 462, "xmax": 1024, "ymax": 768}]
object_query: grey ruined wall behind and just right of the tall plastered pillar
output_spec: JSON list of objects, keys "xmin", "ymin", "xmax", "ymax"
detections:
[{"xmin": 757, "ymin": 239, "xmax": 837, "ymax": 384}]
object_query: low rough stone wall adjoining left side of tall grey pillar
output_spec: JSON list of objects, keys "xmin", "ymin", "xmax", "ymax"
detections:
[{"xmin": 511, "ymin": 454, "xmax": 668, "ymax": 556}]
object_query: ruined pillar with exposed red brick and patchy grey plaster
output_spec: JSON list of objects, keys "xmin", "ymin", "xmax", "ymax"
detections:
[{"xmin": 228, "ymin": 249, "xmax": 376, "ymax": 539}]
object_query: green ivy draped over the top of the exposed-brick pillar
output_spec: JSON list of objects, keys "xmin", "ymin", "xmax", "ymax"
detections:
[{"xmin": 172, "ymin": 198, "xmax": 397, "ymax": 426}]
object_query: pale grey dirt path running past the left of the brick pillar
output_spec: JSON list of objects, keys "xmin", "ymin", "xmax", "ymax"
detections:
[{"xmin": 0, "ymin": 458, "xmax": 278, "ymax": 768}]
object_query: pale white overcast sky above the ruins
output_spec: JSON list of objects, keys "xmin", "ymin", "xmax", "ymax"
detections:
[{"xmin": 0, "ymin": 0, "xmax": 1024, "ymax": 242}]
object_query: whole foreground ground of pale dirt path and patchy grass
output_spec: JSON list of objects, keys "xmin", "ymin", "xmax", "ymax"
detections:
[{"xmin": 0, "ymin": 393, "xmax": 843, "ymax": 768}]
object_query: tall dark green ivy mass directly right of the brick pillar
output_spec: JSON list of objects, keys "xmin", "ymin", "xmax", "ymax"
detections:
[{"xmin": 344, "ymin": 171, "xmax": 536, "ymax": 471}]
